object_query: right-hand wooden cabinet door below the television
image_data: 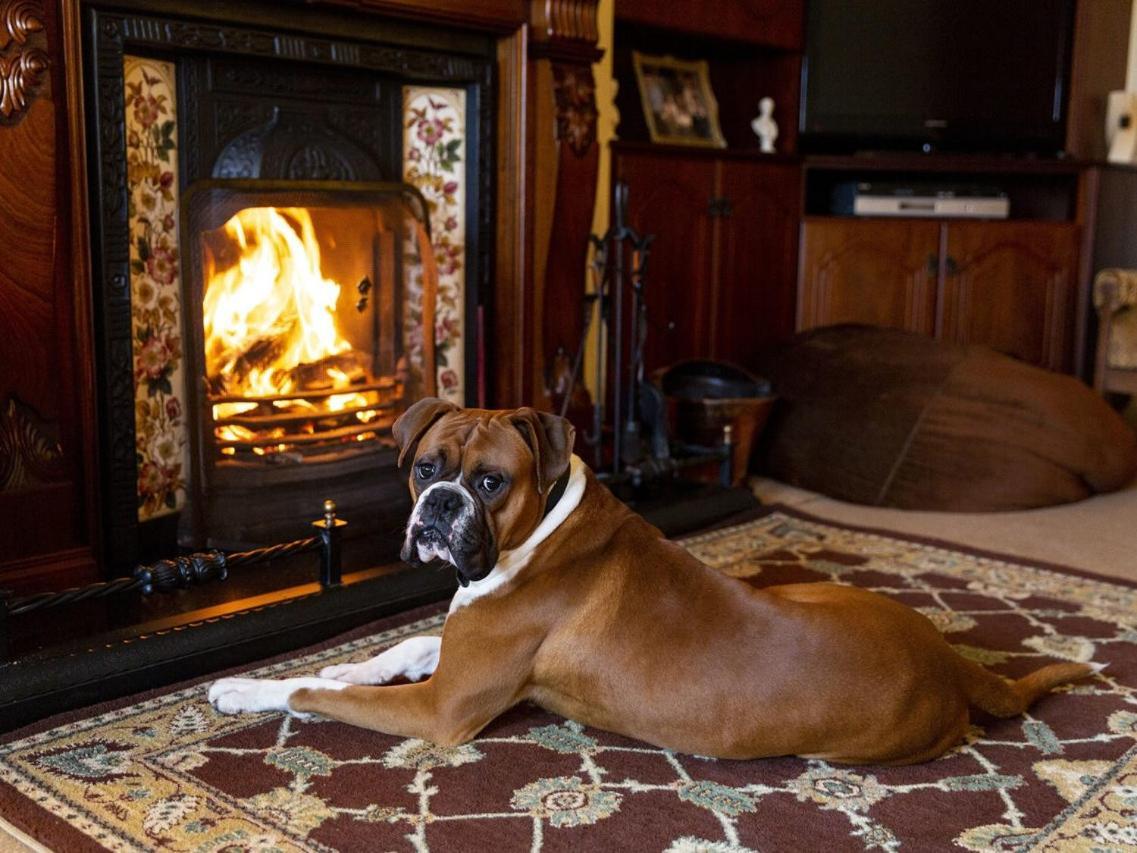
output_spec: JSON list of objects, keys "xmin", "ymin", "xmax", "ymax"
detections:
[{"xmin": 941, "ymin": 222, "xmax": 1078, "ymax": 370}]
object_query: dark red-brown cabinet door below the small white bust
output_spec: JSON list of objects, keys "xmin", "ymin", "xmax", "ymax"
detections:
[{"xmin": 711, "ymin": 162, "xmax": 800, "ymax": 366}]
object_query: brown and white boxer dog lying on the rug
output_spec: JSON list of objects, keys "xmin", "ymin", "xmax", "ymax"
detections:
[{"xmin": 209, "ymin": 399, "xmax": 1097, "ymax": 764}]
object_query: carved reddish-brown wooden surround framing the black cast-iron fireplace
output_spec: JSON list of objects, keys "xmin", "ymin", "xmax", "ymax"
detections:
[{"xmin": 0, "ymin": 0, "xmax": 598, "ymax": 591}]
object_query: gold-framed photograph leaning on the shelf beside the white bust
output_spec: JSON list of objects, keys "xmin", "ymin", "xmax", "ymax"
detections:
[{"xmin": 632, "ymin": 51, "xmax": 727, "ymax": 148}]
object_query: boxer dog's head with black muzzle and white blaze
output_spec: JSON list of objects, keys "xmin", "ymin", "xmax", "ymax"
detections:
[{"xmin": 393, "ymin": 398, "xmax": 574, "ymax": 586}]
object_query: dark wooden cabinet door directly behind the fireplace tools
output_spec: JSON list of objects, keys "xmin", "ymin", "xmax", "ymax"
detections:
[{"xmin": 613, "ymin": 154, "xmax": 714, "ymax": 371}]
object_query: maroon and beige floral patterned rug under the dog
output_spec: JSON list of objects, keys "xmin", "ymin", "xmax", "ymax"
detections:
[{"xmin": 0, "ymin": 508, "xmax": 1137, "ymax": 853}]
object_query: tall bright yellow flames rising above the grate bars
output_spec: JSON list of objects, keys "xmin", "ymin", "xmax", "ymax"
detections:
[{"xmin": 202, "ymin": 207, "xmax": 351, "ymax": 404}]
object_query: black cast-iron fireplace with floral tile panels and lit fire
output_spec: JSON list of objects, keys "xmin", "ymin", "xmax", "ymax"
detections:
[{"xmin": 85, "ymin": 7, "xmax": 496, "ymax": 569}]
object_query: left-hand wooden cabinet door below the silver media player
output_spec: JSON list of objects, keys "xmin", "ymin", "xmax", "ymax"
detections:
[{"xmin": 797, "ymin": 218, "xmax": 939, "ymax": 334}]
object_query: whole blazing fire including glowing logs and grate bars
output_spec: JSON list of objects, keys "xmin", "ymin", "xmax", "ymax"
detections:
[{"xmin": 202, "ymin": 207, "xmax": 379, "ymax": 456}]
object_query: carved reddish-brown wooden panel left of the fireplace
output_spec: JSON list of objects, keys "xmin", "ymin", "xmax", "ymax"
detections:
[{"xmin": 0, "ymin": 0, "xmax": 96, "ymax": 589}]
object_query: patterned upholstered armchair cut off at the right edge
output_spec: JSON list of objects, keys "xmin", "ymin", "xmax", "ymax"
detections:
[{"xmin": 1094, "ymin": 270, "xmax": 1137, "ymax": 394}]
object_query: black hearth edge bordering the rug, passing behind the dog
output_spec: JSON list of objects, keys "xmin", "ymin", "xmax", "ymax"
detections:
[{"xmin": 0, "ymin": 483, "xmax": 760, "ymax": 731}]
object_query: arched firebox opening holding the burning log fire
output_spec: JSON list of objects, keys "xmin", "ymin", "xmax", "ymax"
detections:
[{"xmin": 181, "ymin": 180, "xmax": 438, "ymax": 547}]
